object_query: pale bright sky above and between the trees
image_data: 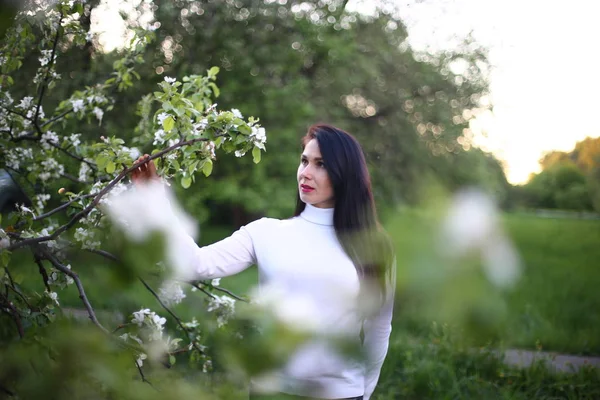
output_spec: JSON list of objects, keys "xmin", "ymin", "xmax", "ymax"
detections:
[{"xmin": 96, "ymin": 0, "xmax": 600, "ymax": 184}]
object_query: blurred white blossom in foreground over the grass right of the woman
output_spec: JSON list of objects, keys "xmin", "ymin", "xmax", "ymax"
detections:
[{"xmin": 442, "ymin": 189, "xmax": 520, "ymax": 287}]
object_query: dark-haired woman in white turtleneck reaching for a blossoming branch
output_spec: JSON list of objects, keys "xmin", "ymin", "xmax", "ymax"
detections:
[{"xmin": 132, "ymin": 125, "xmax": 394, "ymax": 400}]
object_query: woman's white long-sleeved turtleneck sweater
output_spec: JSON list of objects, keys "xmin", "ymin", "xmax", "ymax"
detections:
[{"xmin": 173, "ymin": 204, "xmax": 393, "ymax": 400}]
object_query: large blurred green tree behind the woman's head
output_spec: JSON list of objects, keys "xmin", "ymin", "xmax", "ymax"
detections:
[{"xmin": 5, "ymin": 0, "xmax": 508, "ymax": 225}]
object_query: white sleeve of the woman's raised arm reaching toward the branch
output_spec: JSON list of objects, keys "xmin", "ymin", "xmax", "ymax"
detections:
[{"xmin": 169, "ymin": 221, "xmax": 259, "ymax": 279}]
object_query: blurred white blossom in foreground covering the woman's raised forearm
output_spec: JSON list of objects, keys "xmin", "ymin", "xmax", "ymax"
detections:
[{"xmin": 103, "ymin": 181, "xmax": 197, "ymax": 279}]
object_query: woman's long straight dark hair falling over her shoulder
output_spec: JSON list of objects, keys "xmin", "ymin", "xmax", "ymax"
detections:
[{"xmin": 294, "ymin": 124, "xmax": 394, "ymax": 293}]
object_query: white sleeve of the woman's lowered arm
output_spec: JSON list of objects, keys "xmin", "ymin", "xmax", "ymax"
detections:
[{"xmin": 363, "ymin": 260, "xmax": 396, "ymax": 400}]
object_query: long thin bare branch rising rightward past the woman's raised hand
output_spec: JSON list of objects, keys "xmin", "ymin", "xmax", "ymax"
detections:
[{"xmin": 7, "ymin": 135, "xmax": 223, "ymax": 251}]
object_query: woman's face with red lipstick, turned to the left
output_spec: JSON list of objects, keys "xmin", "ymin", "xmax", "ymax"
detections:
[{"xmin": 298, "ymin": 139, "xmax": 335, "ymax": 208}]
